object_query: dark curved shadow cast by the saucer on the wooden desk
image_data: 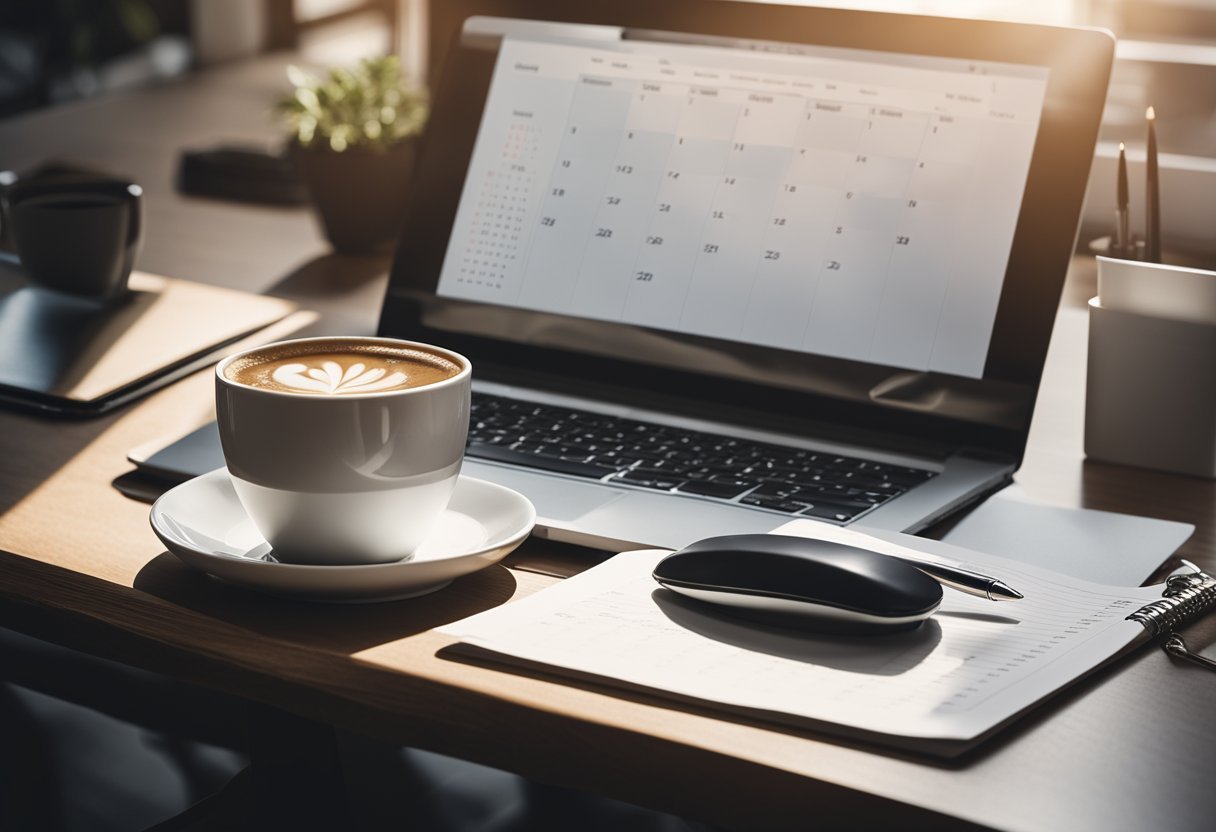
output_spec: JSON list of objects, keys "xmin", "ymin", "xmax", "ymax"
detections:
[{"xmin": 134, "ymin": 552, "xmax": 516, "ymax": 654}]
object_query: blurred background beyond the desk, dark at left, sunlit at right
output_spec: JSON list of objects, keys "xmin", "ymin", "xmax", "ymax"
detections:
[{"xmin": 0, "ymin": 0, "xmax": 1216, "ymax": 242}]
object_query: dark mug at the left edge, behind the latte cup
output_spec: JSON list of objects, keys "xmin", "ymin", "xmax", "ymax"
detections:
[{"xmin": 6, "ymin": 176, "xmax": 142, "ymax": 299}]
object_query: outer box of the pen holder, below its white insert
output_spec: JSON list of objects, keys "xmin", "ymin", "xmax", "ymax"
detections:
[{"xmin": 1085, "ymin": 298, "xmax": 1216, "ymax": 478}]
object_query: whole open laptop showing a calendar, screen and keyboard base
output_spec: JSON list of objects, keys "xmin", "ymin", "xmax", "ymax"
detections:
[{"xmin": 378, "ymin": 0, "xmax": 1113, "ymax": 549}]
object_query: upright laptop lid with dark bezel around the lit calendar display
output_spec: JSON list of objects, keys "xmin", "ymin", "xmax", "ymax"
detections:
[{"xmin": 381, "ymin": 2, "xmax": 1109, "ymax": 462}]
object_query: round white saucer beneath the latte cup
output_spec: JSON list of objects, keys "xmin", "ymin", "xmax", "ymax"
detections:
[{"xmin": 150, "ymin": 468, "xmax": 536, "ymax": 602}]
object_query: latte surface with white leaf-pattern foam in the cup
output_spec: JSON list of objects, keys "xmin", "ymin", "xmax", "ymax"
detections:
[{"xmin": 224, "ymin": 339, "xmax": 461, "ymax": 395}]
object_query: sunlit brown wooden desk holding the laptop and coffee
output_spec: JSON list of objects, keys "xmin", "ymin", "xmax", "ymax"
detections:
[{"xmin": 0, "ymin": 60, "xmax": 1216, "ymax": 831}]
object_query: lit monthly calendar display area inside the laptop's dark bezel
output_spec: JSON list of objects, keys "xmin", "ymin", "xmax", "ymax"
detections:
[{"xmin": 438, "ymin": 38, "xmax": 1047, "ymax": 377}]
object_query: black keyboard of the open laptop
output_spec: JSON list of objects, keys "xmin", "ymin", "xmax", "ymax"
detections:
[{"xmin": 468, "ymin": 393, "xmax": 934, "ymax": 523}]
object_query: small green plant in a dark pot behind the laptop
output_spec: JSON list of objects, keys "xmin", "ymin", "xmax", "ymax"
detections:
[{"xmin": 277, "ymin": 56, "xmax": 428, "ymax": 254}]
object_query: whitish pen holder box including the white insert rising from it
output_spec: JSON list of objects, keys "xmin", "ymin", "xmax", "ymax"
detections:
[{"xmin": 1085, "ymin": 257, "xmax": 1216, "ymax": 478}]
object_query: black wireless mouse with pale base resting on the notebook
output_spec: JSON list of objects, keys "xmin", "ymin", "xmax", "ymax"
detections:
[{"xmin": 654, "ymin": 534, "xmax": 941, "ymax": 634}]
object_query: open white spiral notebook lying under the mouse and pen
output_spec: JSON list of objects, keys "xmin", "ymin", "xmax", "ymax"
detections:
[{"xmin": 440, "ymin": 521, "xmax": 1216, "ymax": 758}]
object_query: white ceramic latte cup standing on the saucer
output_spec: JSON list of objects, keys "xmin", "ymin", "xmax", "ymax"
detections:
[{"xmin": 215, "ymin": 337, "xmax": 472, "ymax": 564}]
